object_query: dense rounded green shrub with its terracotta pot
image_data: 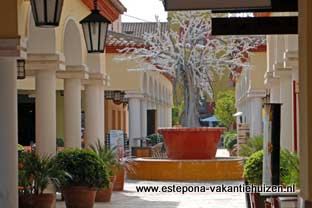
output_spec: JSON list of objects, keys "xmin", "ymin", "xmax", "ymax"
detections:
[{"xmin": 56, "ymin": 149, "xmax": 109, "ymax": 208}]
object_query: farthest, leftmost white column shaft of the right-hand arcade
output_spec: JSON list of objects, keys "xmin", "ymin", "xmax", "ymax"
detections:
[{"xmin": 250, "ymin": 97, "xmax": 263, "ymax": 137}]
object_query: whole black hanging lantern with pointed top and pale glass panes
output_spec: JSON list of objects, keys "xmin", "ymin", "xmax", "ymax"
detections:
[{"xmin": 80, "ymin": 0, "xmax": 111, "ymax": 53}]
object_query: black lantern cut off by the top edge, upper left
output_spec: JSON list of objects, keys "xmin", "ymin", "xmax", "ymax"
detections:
[{"xmin": 30, "ymin": 0, "xmax": 64, "ymax": 27}]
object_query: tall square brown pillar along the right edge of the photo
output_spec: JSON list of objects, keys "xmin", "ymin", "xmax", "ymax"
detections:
[{"xmin": 298, "ymin": 0, "xmax": 312, "ymax": 205}]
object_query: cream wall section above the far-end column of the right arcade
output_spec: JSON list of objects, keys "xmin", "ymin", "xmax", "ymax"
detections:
[{"xmin": 249, "ymin": 52, "xmax": 267, "ymax": 90}]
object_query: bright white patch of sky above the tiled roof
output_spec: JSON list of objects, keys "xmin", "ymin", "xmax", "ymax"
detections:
[{"xmin": 120, "ymin": 0, "xmax": 167, "ymax": 22}]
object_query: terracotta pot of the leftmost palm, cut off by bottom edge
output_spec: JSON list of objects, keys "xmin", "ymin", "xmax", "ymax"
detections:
[{"xmin": 18, "ymin": 194, "xmax": 55, "ymax": 208}]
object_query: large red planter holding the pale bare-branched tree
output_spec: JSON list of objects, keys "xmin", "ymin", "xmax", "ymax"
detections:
[{"xmin": 158, "ymin": 128, "xmax": 225, "ymax": 160}]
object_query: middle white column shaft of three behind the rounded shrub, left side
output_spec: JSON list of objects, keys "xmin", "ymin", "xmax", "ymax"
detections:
[{"xmin": 64, "ymin": 79, "xmax": 81, "ymax": 148}]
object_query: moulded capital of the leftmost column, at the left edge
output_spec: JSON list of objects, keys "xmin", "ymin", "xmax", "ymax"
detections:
[{"xmin": 0, "ymin": 37, "xmax": 27, "ymax": 59}]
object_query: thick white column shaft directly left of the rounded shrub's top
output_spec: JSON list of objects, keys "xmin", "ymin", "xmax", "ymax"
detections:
[{"xmin": 36, "ymin": 69, "xmax": 56, "ymax": 155}]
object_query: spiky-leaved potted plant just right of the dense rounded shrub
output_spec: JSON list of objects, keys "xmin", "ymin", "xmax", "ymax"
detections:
[{"xmin": 90, "ymin": 140, "xmax": 122, "ymax": 202}]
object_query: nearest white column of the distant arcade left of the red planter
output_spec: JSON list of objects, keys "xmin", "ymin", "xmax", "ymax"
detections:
[{"xmin": 129, "ymin": 97, "xmax": 142, "ymax": 148}]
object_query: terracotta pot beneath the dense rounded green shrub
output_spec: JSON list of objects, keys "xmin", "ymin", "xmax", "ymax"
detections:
[{"xmin": 63, "ymin": 186, "xmax": 96, "ymax": 208}]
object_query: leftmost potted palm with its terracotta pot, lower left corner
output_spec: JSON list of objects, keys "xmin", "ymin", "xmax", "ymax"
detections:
[{"xmin": 19, "ymin": 152, "xmax": 66, "ymax": 208}]
